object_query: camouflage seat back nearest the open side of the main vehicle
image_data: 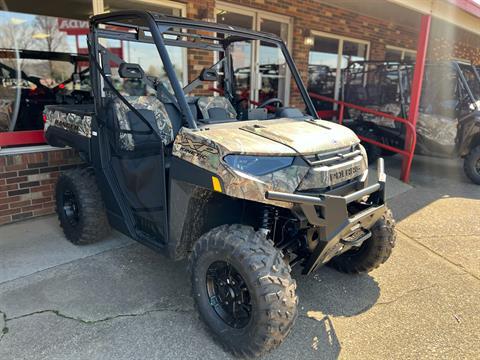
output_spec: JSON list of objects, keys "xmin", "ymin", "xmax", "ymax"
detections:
[{"xmin": 113, "ymin": 96, "xmax": 175, "ymax": 151}]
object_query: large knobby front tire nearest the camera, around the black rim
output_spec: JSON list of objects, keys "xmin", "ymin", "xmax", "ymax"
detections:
[{"xmin": 189, "ymin": 225, "xmax": 298, "ymax": 357}]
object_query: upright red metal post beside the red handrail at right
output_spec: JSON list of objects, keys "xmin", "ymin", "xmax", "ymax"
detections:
[{"xmin": 401, "ymin": 15, "xmax": 432, "ymax": 183}]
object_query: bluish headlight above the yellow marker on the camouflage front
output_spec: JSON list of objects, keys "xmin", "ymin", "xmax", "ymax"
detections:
[{"xmin": 223, "ymin": 155, "xmax": 294, "ymax": 176}]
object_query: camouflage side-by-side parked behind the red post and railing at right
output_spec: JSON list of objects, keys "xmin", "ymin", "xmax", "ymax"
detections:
[{"xmin": 342, "ymin": 61, "xmax": 480, "ymax": 184}]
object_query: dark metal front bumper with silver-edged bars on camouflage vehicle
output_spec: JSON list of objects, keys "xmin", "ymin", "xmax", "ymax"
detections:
[{"xmin": 265, "ymin": 159, "xmax": 386, "ymax": 274}]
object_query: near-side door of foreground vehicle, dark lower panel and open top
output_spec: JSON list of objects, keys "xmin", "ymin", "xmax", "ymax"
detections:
[{"xmin": 92, "ymin": 37, "xmax": 173, "ymax": 246}]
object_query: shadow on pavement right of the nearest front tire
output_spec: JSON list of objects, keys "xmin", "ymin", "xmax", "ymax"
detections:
[{"xmin": 267, "ymin": 267, "xmax": 380, "ymax": 359}]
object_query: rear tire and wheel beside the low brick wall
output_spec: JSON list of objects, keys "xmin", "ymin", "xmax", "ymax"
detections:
[{"xmin": 55, "ymin": 168, "xmax": 111, "ymax": 245}]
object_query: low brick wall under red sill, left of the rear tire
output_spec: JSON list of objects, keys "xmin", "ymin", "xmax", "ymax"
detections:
[{"xmin": 0, "ymin": 149, "xmax": 81, "ymax": 224}]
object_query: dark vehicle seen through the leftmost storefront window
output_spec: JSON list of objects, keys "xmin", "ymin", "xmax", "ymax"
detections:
[{"xmin": 0, "ymin": 49, "xmax": 93, "ymax": 131}]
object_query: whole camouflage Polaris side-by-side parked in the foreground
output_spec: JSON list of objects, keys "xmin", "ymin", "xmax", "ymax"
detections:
[{"xmin": 45, "ymin": 11, "xmax": 395, "ymax": 356}]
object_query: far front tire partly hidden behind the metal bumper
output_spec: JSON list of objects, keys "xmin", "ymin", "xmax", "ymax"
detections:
[{"xmin": 328, "ymin": 209, "xmax": 396, "ymax": 274}]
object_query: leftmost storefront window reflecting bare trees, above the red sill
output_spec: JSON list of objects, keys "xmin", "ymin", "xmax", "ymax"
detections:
[{"xmin": 0, "ymin": 10, "xmax": 92, "ymax": 132}]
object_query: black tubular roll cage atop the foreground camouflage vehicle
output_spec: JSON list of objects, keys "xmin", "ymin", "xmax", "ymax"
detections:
[{"xmin": 89, "ymin": 10, "xmax": 317, "ymax": 129}]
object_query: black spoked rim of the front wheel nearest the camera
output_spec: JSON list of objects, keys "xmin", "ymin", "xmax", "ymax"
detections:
[{"xmin": 206, "ymin": 261, "xmax": 252, "ymax": 329}]
